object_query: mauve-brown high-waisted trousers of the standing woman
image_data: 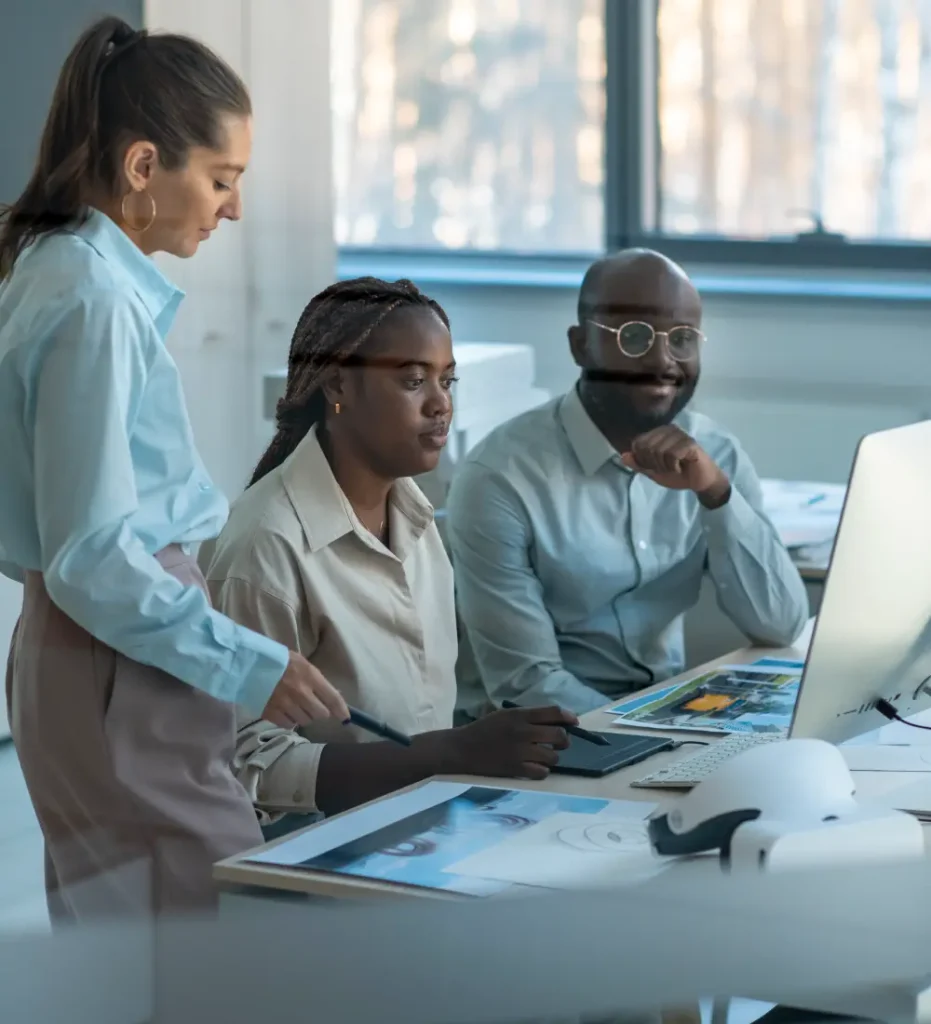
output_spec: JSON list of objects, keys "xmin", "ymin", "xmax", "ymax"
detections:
[{"xmin": 6, "ymin": 547, "xmax": 262, "ymax": 923}]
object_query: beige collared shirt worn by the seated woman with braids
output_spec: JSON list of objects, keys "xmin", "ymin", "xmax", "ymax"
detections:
[{"xmin": 201, "ymin": 423, "xmax": 457, "ymax": 815}]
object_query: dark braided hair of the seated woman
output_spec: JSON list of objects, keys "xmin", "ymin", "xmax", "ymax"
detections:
[{"xmin": 249, "ymin": 278, "xmax": 450, "ymax": 486}]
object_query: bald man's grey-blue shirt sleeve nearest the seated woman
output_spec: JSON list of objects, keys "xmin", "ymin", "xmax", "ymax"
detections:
[{"xmin": 447, "ymin": 463, "xmax": 605, "ymax": 714}]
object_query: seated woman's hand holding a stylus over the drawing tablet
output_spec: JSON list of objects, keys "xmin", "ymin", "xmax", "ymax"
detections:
[{"xmin": 432, "ymin": 708, "xmax": 579, "ymax": 779}]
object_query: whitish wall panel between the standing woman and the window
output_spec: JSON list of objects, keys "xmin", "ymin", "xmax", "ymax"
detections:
[{"xmin": 145, "ymin": 0, "xmax": 335, "ymax": 499}]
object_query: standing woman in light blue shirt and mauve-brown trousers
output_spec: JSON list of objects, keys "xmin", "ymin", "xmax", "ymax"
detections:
[{"xmin": 0, "ymin": 17, "xmax": 348, "ymax": 920}]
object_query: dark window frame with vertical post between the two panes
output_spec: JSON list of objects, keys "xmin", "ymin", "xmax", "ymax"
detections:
[{"xmin": 338, "ymin": 0, "xmax": 931, "ymax": 280}]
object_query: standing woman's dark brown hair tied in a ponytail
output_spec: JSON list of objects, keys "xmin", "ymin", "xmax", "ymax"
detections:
[{"xmin": 0, "ymin": 17, "xmax": 251, "ymax": 281}]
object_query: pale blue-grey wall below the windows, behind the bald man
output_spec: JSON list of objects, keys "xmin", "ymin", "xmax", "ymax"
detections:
[{"xmin": 429, "ymin": 280, "xmax": 931, "ymax": 481}]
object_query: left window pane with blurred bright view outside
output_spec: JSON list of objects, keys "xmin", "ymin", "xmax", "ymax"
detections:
[{"xmin": 332, "ymin": 0, "xmax": 605, "ymax": 253}]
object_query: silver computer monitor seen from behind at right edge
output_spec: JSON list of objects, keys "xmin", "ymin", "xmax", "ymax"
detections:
[{"xmin": 790, "ymin": 421, "xmax": 931, "ymax": 743}]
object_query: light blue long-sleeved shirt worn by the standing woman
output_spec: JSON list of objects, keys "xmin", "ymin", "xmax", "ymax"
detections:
[{"xmin": 0, "ymin": 203, "xmax": 288, "ymax": 712}]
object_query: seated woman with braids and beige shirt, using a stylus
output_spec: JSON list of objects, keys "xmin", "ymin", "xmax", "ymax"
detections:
[{"xmin": 205, "ymin": 278, "xmax": 576, "ymax": 823}]
